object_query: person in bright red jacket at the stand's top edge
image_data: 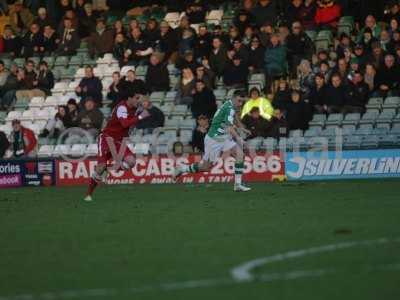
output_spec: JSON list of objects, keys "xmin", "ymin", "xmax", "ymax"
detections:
[{"xmin": 315, "ymin": 0, "xmax": 342, "ymax": 28}]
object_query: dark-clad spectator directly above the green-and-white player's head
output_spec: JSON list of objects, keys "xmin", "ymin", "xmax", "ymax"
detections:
[{"xmin": 223, "ymin": 54, "xmax": 249, "ymax": 89}]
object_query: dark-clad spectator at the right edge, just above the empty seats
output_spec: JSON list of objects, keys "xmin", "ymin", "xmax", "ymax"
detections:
[{"xmin": 375, "ymin": 54, "xmax": 400, "ymax": 96}]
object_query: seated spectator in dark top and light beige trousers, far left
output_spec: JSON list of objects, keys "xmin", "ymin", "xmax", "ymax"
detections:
[{"xmin": 15, "ymin": 60, "xmax": 46, "ymax": 101}]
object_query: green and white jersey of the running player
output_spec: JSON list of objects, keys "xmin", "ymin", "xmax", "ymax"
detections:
[{"xmin": 208, "ymin": 100, "xmax": 236, "ymax": 141}]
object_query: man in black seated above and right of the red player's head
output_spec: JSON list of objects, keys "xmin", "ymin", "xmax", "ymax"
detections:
[{"xmin": 145, "ymin": 53, "xmax": 170, "ymax": 92}]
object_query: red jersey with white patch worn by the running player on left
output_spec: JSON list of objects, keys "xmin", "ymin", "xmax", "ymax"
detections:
[{"xmin": 102, "ymin": 101, "xmax": 139, "ymax": 141}]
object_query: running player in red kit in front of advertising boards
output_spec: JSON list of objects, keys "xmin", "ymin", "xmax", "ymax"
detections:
[{"xmin": 84, "ymin": 93, "xmax": 149, "ymax": 201}]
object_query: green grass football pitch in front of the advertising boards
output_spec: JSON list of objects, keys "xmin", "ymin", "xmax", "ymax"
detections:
[{"xmin": 0, "ymin": 180, "xmax": 400, "ymax": 300}]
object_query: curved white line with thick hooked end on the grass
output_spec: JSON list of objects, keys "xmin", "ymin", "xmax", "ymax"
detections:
[{"xmin": 231, "ymin": 238, "xmax": 400, "ymax": 282}]
